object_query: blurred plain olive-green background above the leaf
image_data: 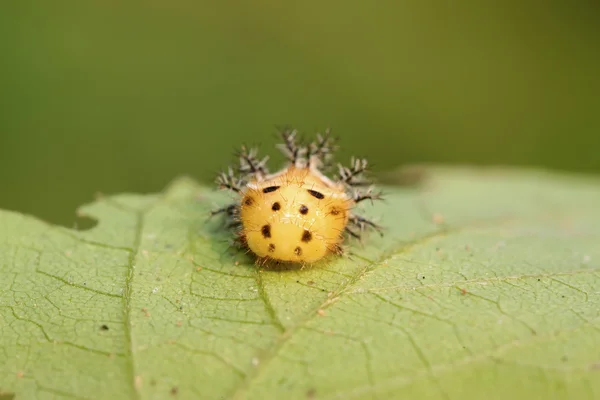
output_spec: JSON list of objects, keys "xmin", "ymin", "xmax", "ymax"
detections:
[{"xmin": 0, "ymin": 0, "xmax": 600, "ymax": 225}]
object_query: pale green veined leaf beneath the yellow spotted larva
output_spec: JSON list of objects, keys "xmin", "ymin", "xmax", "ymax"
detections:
[{"xmin": 0, "ymin": 169, "xmax": 600, "ymax": 399}]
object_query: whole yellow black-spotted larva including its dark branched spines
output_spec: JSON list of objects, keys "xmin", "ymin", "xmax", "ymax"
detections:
[{"xmin": 211, "ymin": 129, "xmax": 382, "ymax": 264}]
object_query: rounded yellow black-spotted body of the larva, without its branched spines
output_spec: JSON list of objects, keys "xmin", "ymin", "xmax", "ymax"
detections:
[{"xmin": 240, "ymin": 169, "xmax": 352, "ymax": 262}]
